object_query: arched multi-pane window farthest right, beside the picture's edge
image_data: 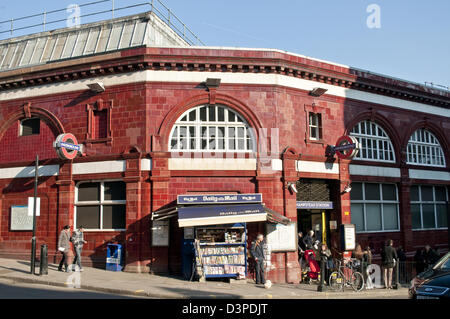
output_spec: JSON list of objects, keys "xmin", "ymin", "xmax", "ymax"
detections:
[{"xmin": 406, "ymin": 129, "xmax": 445, "ymax": 167}]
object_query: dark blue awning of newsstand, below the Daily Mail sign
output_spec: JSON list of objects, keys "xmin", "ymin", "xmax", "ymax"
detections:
[{"xmin": 152, "ymin": 204, "xmax": 290, "ymax": 227}]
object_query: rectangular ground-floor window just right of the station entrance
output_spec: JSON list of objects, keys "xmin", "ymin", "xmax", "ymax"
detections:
[{"xmin": 350, "ymin": 182, "xmax": 400, "ymax": 232}]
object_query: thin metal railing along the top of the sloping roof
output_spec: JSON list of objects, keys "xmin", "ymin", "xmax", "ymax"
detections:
[{"xmin": 0, "ymin": 0, "xmax": 205, "ymax": 45}]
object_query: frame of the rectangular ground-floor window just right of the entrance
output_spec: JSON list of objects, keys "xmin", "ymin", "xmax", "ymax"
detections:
[{"xmin": 350, "ymin": 181, "xmax": 401, "ymax": 234}]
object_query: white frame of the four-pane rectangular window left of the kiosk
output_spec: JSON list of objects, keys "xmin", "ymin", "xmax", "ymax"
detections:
[{"xmin": 73, "ymin": 179, "xmax": 127, "ymax": 232}]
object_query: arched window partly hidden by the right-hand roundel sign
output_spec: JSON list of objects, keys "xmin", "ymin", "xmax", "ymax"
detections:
[{"xmin": 350, "ymin": 121, "xmax": 395, "ymax": 163}]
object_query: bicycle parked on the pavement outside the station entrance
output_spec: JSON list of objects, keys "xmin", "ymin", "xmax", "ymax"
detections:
[{"xmin": 328, "ymin": 258, "xmax": 364, "ymax": 292}]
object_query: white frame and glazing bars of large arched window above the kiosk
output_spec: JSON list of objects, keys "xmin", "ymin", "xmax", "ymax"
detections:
[{"xmin": 168, "ymin": 104, "xmax": 256, "ymax": 153}]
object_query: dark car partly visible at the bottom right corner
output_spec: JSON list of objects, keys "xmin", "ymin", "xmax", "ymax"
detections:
[{"xmin": 409, "ymin": 252, "xmax": 450, "ymax": 298}]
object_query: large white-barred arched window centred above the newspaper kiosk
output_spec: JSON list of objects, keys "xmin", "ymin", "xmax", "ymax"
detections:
[{"xmin": 169, "ymin": 105, "xmax": 256, "ymax": 152}]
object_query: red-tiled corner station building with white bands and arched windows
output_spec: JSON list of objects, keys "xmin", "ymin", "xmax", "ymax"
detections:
[{"xmin": 0, "ymin": 15, "xmax": 450, "ymax": 282}]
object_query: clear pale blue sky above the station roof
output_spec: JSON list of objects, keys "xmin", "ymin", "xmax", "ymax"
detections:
[{"xmin": 0, "ymin": 0, "xmax": 450, "ymax": 86}]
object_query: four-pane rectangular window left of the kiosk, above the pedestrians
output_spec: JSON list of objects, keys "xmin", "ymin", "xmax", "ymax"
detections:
[{"xmin": 75, "ymin": 182, "xmax": 126, "ymax": 230}]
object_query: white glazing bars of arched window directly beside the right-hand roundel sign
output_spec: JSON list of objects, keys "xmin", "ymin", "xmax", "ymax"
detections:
[{"xmin": 350, "ymin": 120, "xmax": 396, "ymax": 163}]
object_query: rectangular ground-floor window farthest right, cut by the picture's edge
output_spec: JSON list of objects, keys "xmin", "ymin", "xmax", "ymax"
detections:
[{"xmin": 410, "ymin": 185, "xmax": 448, "ymax": 230}]
